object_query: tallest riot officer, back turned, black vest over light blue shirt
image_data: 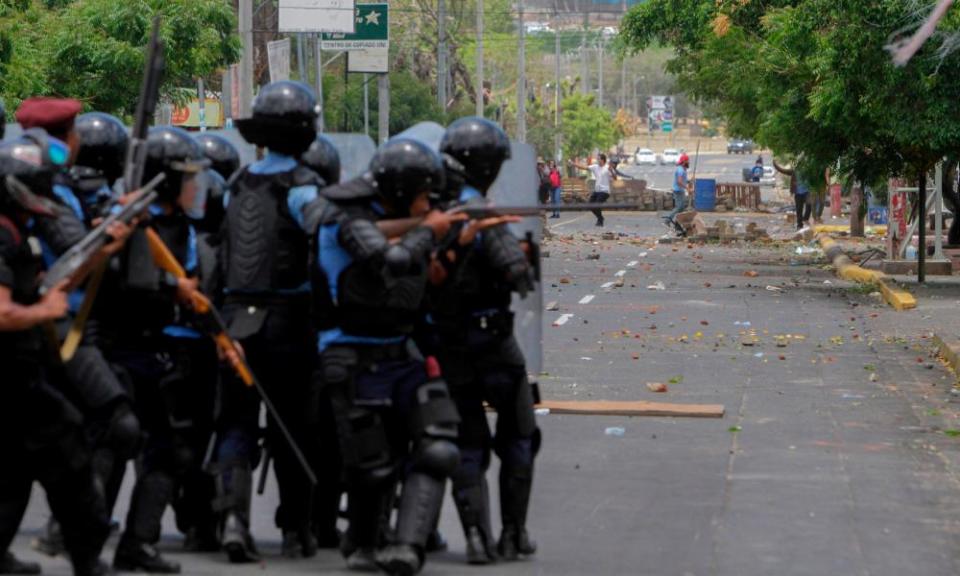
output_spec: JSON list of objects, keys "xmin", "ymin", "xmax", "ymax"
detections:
[{"xmin": 215, "ymin": 81, "xmax": 324, "ymax": 562}]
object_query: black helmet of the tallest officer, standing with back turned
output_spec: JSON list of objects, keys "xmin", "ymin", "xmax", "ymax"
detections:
[{"xmin": 235, "ymin": 80, "xmax": 320, "ymax": 156}]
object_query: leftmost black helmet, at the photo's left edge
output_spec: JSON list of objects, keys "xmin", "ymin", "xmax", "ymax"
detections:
[{"xmin": 0, "ymin": 128, "xmax": 69, "ymax": 215}]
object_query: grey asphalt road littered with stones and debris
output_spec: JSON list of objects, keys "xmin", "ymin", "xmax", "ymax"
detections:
[{"xmin": 11, "ymin": 213, "xmax": 960, "ymax": 576}]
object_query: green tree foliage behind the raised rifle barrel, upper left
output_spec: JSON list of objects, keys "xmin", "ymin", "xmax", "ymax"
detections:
[{"xmin": 0, "ymin": 0, "xmax": 240, "ymax": 115}]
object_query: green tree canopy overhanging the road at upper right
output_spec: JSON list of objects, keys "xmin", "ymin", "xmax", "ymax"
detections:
[{"xmin": 622, "ymin": 0, "xmax": 960, "ymax": 183}]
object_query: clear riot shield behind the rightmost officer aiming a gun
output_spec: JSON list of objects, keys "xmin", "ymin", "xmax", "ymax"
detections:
[{"xmin": 487, "ymin": 142, "xmax": 543, "ymax": 382}]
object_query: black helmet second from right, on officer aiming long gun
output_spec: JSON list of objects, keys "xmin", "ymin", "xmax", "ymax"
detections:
[{"xmin": 370, "ymin": 138, "xmax": 446, "ymax": 213}]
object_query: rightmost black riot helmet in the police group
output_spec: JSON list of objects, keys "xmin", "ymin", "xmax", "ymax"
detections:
[{"xmin": 440, "ymin": 116, "xmax": 510, "ymax": 193}]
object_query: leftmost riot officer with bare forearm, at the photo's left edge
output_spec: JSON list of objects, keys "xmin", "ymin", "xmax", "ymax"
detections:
[{"xmin": 0, "ymin": 138, "xmax": 108, "ymax": 576}]
